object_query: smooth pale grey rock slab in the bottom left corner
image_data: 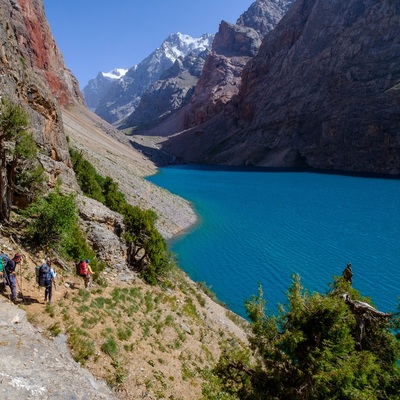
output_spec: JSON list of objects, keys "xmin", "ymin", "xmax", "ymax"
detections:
[{"xmin": 0, "ymin": 297, "xmax": 116, "ymax": 400}]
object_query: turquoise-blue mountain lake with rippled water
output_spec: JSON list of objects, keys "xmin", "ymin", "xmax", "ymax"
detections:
[{"xmin": 147, "ymin": 166, "xmax": 400, "ymax": 316}]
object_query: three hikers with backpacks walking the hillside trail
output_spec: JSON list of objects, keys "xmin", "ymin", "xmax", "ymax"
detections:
[{"xmin": 0, "ymin": 253, "xmax": 93, "ymax": 304}]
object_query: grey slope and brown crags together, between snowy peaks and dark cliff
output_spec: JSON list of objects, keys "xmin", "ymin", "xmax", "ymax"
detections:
[{"xmin": 99, "ymin": 0, "xmax": 293, "ymax": 136}]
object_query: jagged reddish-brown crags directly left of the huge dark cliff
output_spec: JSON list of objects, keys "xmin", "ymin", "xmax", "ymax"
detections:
[{"xmin": 184, "ymin": 0, "xmax": 293, "ymax": 129}]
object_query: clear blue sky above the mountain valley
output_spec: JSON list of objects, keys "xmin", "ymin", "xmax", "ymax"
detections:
[{"xmin": 43, "ymin": 0, "xmax": 254, "ymax": 88}]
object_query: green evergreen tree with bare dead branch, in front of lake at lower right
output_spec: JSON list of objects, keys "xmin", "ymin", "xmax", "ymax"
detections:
[{"xmin": 212, "ymin": 276, "xmax": 400, "ymax": 400}]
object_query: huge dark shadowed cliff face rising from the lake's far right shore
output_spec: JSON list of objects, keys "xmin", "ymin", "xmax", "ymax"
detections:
[{"xmin": 166, "ymin": 0, "xmax": 400, "ymax": 174}]
